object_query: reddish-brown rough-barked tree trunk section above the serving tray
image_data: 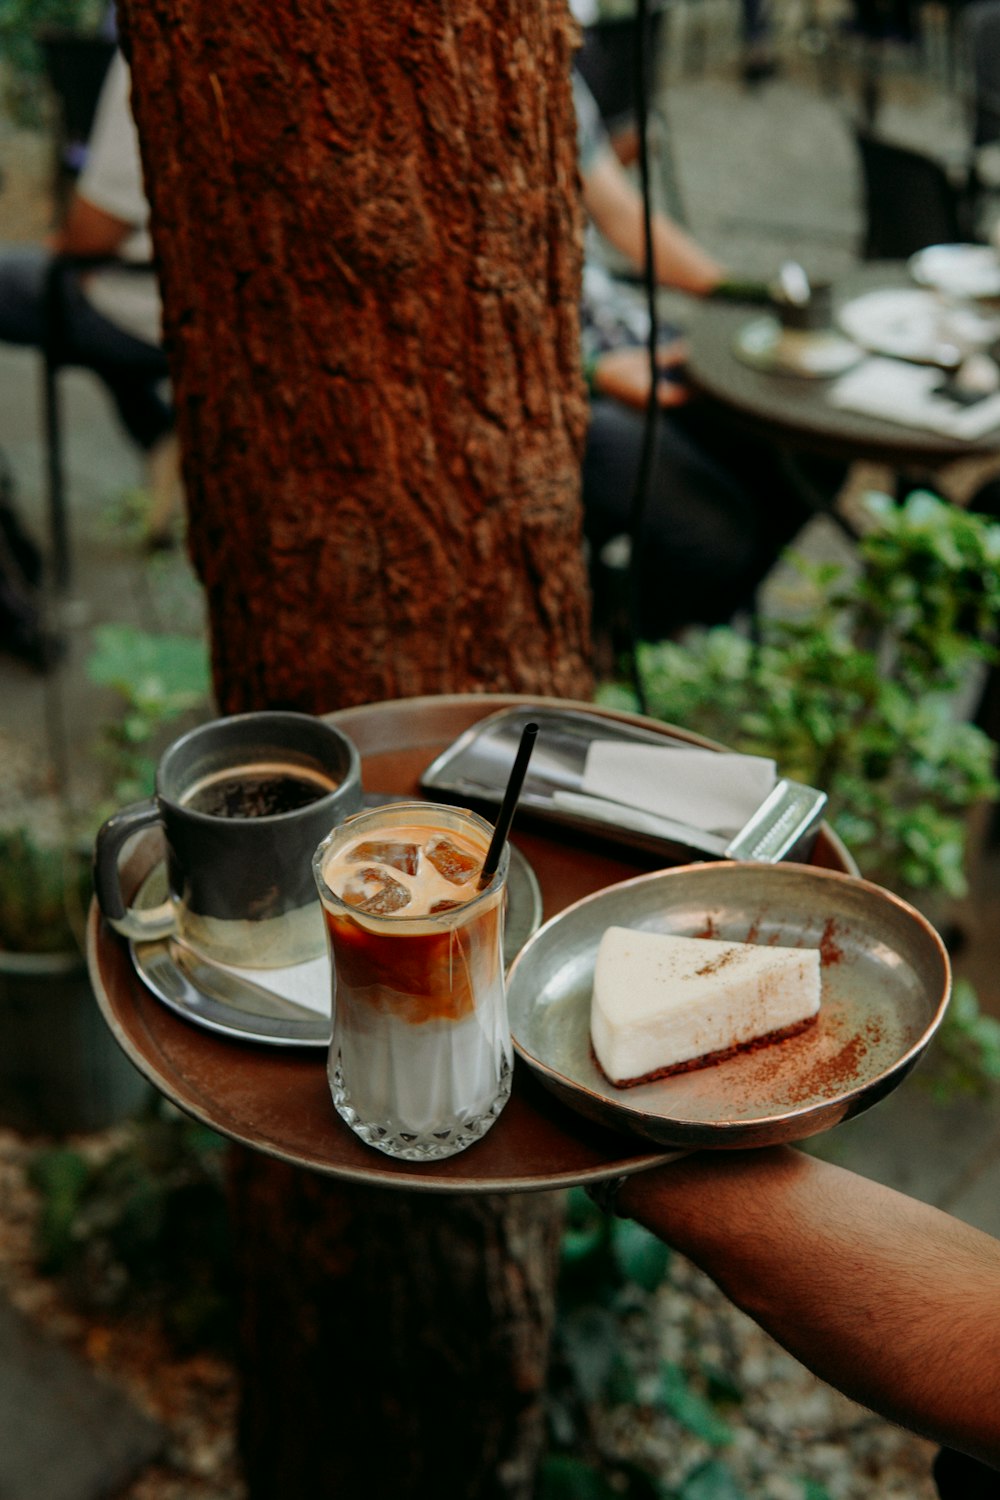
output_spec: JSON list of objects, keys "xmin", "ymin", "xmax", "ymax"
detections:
[{"xmin": 127, "ymin": 0, "xmax": 589, "ymax": 713}]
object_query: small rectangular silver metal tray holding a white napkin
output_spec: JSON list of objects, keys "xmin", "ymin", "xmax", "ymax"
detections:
[{"xmin": 420, "ymin": 705, "xmax": 826, "ymax": 864}]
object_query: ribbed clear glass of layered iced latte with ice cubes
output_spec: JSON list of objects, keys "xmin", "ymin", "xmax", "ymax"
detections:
[{"xmin": 313, "ymin": 803, "xmax": 513, "ymax": 1161}]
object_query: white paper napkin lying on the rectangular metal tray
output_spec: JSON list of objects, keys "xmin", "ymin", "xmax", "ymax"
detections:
[{"xmin": 556, "ymin": 740, "xmax": 777, "ymax": 837}]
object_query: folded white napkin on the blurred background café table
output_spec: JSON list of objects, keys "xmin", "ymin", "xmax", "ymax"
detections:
[{"xmin": 829, "ymin": 357, "xmax": 1000, "ymax": 438}]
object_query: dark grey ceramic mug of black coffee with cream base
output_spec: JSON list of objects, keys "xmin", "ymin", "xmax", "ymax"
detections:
[{"xmin": 94, "ymin": 711, "xmax": 361, "ymax": 969}]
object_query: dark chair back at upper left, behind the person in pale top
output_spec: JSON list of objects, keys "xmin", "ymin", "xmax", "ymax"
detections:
[{"xmin": 37, "ymin": 27, "xmax": 117, "ymax": 219}]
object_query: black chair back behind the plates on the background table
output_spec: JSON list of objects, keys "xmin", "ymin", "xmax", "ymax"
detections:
[{"xmin": 855, "ymin": 126, "xmax": 975, "ymax": 261}]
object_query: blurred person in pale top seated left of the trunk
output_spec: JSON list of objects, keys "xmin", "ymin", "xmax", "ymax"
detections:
[{"xmin": 0, "ymin": 53, "xmax": 180, "ymax": 561}]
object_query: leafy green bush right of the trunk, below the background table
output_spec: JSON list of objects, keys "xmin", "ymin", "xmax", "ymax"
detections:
[{"xmin": 611, "ymin": 492, "xmax": 1000, "ymax": 896}]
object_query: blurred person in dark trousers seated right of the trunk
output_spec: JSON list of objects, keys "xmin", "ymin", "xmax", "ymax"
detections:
[{"xmin": 573, "ymin": 75, "xmax": 846, "ymax": 641}]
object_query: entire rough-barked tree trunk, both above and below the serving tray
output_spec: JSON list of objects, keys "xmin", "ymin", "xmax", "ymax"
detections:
[{"xmin": 121, "ymin": 0, "xmax": 591, "ymax": 1500}]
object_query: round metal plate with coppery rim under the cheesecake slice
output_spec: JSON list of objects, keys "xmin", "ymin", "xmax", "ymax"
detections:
[{"xmin": 508, "ymin": 863, "xmax": 951, "ymax": 1149}]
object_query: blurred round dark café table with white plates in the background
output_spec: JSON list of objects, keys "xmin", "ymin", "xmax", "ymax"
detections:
[{"xmin": 687, "ymin": 261, "xmax": 1000, "ymax": 473}]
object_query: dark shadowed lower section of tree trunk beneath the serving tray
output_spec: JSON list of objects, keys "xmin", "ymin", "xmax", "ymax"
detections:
[{"xmin": 231, "ymin": 1152, "xmax": 561, "ymax": 1500}]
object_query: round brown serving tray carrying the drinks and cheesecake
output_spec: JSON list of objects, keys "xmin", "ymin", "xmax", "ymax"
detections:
[{"xmin": 87, "ymin": 693, "xmax": 856, "ymax": 1193}]
